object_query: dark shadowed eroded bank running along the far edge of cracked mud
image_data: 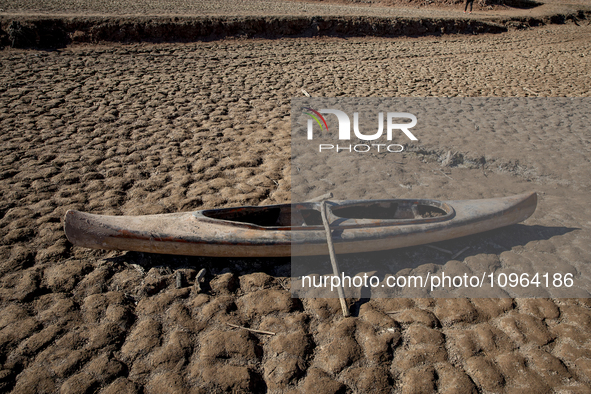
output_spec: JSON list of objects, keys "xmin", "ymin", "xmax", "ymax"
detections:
[{"xmin": 0, "ymin": 11, "xmax": 588, "ymax": 48}]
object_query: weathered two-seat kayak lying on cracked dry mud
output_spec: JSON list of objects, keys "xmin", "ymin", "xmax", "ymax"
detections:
[{"xmin": 64, "ymin": 193, "xmax": 537, "ymax": 257}]
